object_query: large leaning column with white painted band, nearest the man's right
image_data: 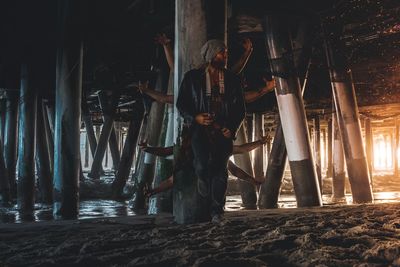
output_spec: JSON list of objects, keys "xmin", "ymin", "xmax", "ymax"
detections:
[{"xmin": 265, "ymin": 15, "xmax": 322, "ymax": 207}]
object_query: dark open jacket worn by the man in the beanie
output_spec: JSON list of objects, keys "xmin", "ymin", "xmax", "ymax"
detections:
[{"xmin": 176, "ymin": 68, "xmax": 245, "ymax": 138}]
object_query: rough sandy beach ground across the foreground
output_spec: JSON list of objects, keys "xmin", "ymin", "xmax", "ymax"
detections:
[{"xmin": 0, "ymin": 203, "xmax": 400, "ymax": 266}]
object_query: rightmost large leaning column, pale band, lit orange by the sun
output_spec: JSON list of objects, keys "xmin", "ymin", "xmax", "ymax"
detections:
[{"xmin": 326, "ymin": 22, "xmax": 373, "ymax": 203}]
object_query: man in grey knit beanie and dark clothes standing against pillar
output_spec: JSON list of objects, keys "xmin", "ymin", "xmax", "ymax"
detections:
[{"xmin": 176, "ymin": 40, "xmax": 245, "ymax": 223}]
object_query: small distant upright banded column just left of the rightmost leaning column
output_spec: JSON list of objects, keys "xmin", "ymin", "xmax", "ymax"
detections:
[{"xmin": 332, "ymin": 113, "xmax": 346, "ymax": 202}]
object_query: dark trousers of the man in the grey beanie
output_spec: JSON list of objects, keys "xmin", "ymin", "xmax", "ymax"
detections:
[{"xmin": 191, "ymin": 125, "xmax": 233, "ymax": 216}]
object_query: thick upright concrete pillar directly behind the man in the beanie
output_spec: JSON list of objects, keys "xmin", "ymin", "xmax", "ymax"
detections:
[{"xmin": 173, "ymin": 0, "xmax": 227, "ymax": 223}]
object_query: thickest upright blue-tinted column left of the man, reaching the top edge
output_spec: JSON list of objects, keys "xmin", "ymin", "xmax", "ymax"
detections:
[{"xmin": 53, "ymin": 0, "xmax": 83, "ymax": 219}]
